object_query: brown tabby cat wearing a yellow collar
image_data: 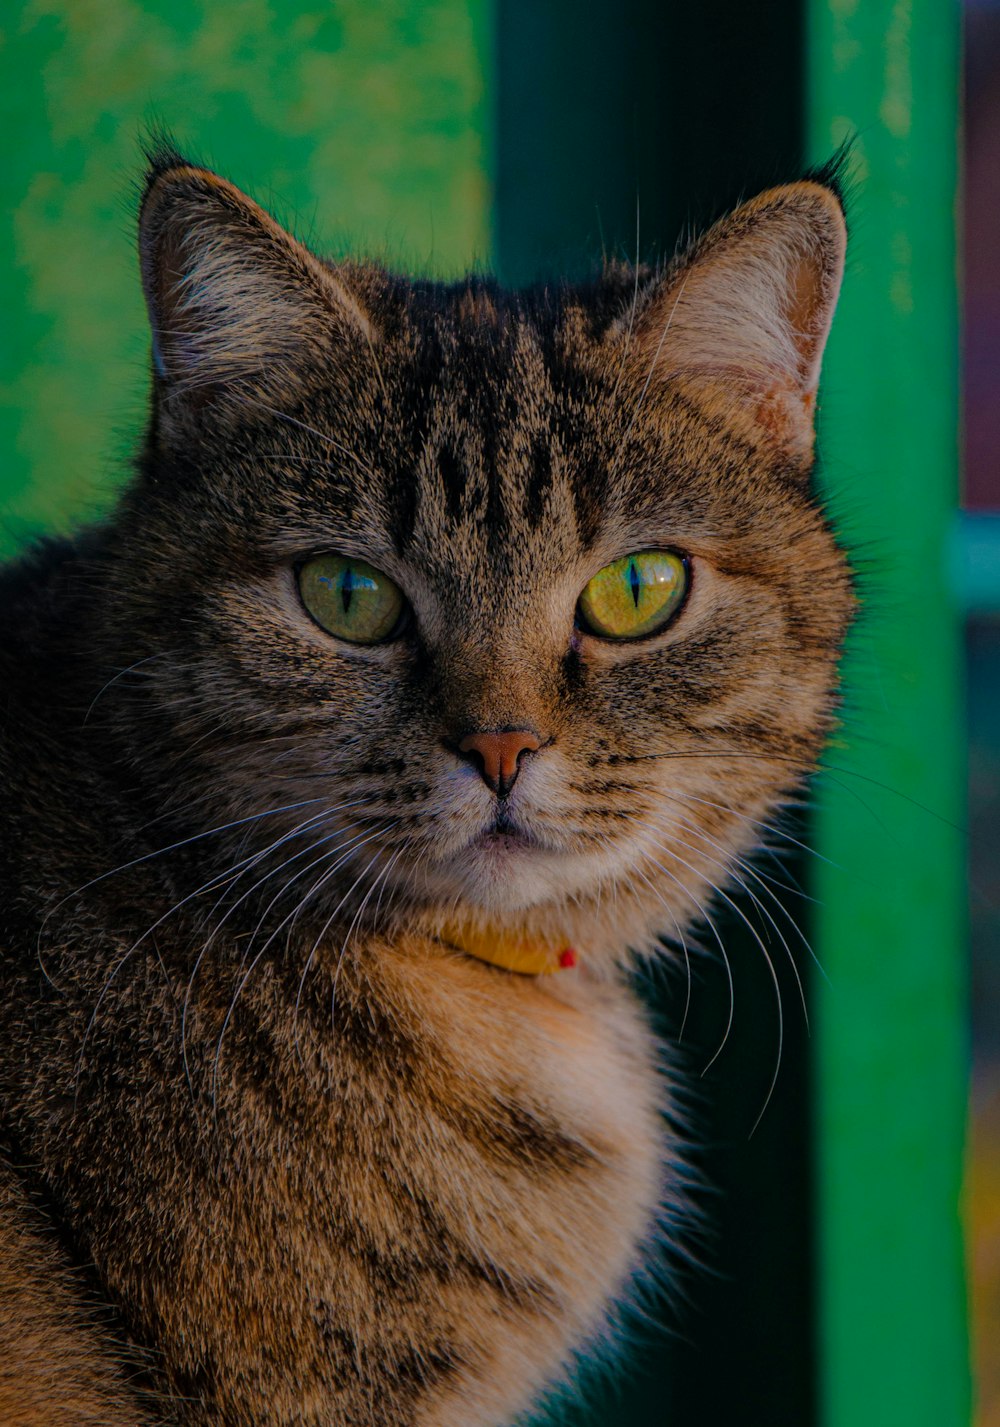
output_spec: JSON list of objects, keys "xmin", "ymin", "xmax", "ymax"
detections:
[{"xmin": 0, "ymin": 146, "xmax": 853, "ymax": 1427}]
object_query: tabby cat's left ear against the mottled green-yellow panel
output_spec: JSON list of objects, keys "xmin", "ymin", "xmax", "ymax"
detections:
[{"xmin": 140, "ymin": 154, "xmax": 375, "ymax": 422}]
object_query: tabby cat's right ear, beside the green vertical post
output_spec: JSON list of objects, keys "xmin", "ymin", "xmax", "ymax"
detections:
[{"xmin": 621, "ymin": 180, "xmax": 847, "ymax": 464}]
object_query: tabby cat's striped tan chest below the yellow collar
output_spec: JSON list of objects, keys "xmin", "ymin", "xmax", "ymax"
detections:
[{"xmin": 146, "ymin": 956, "xmax": 662, "ymax": 1424}]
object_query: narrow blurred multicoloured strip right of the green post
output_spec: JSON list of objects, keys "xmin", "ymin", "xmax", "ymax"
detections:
[{"xmin": 959, "ymin": 0, "xmax": 1000, "ymax": 1427}]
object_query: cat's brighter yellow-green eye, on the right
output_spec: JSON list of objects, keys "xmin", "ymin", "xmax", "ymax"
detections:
[{"xmin": 578, "ymin": 549, "xmax": 688, "ymax": 639}]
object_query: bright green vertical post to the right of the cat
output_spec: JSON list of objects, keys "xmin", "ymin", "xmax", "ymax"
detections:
[{"xmin": 807, "ymin": 0, "xmax": 970, "ymax": 1427}]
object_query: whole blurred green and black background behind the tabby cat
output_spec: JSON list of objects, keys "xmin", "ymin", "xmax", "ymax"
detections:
[{"xmin": 0, "ymin": 0, "xmax": 1000, "ymax": 1427}]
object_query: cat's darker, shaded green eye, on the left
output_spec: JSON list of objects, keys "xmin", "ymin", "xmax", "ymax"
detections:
[{"xmin": 298, "ymin": 555, "xmax": 405, "ymax": 644}]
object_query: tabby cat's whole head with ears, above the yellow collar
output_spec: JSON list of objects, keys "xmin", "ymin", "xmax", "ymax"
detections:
[{"xmin": 99, "ymin": 154, "xmax": 850, "ymax": 981}]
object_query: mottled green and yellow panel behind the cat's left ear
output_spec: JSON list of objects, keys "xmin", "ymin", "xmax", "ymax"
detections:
[{"xmin": 0, "ymin": 0, "xmax": 492, "ymax": 555}]
